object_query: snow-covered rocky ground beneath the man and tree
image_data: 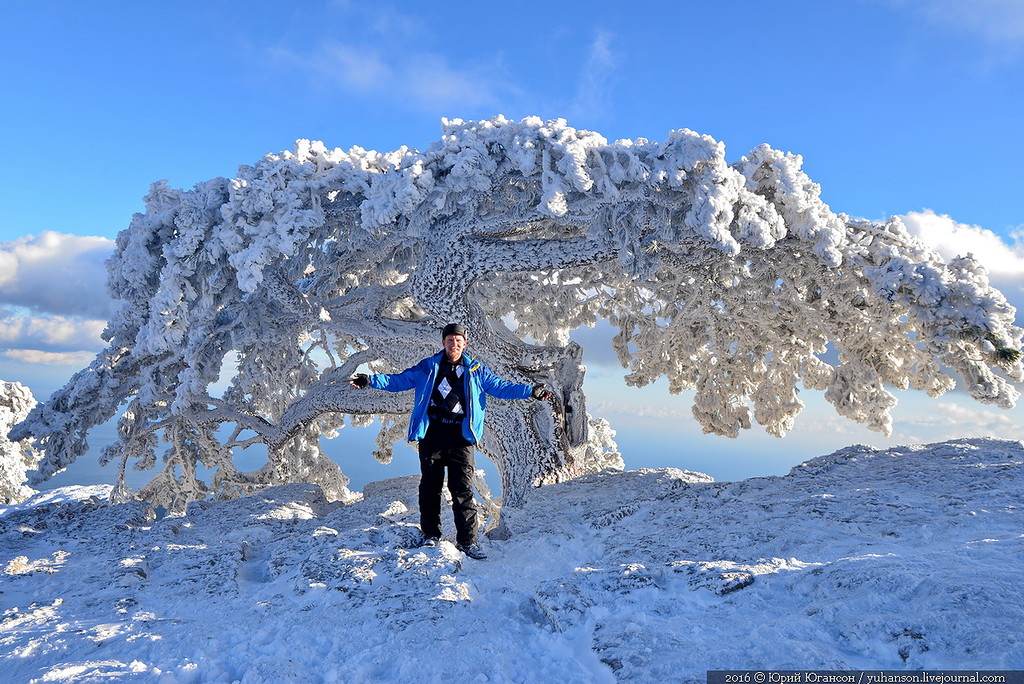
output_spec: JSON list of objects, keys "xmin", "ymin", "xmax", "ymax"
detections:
[{"xmin": 0, "ymin": 439, "xmax": 1024, "ymax": 682}]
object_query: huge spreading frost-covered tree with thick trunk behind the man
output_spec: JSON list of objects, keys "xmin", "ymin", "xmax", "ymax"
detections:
[{"xmin": 13, "ymin": 117, "xmax": 1024, "ymax": 507}]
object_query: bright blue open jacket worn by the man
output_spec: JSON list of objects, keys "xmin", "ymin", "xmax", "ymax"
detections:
[{"xmin": 370, "ymin": 350, "xmax": 534, "ymax": 444}]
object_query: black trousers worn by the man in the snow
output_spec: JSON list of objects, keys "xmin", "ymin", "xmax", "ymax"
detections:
[{"xmin": 419, "ymin": 421, "xmax": 477, "ymax": 546}]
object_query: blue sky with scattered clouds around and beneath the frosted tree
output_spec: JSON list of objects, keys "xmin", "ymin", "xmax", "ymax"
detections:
[{"xmin": 0, "ymin": 0, "xmax": 1024, "ymax": 491}]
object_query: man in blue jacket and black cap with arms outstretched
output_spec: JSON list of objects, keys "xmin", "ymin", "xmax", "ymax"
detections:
[{"xmin": 351, "ymin": 324, "xmax": 551, "ymax": 560}]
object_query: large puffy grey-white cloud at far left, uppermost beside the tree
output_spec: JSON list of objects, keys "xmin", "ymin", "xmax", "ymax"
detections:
[{"xmin": 0, "ymin": 230, "xmax": 115, "ymax": 318}]
